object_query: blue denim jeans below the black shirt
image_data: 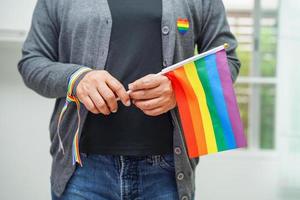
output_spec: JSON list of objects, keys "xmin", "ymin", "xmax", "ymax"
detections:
[{"xmin": 52, "ymin": 153, "xmax": 179, "ymax": 200}]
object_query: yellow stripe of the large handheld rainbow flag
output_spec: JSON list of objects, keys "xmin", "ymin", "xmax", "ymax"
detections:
[{"xmin": 184, "ymin": 62, "xmax": 218, "ymax": 153}]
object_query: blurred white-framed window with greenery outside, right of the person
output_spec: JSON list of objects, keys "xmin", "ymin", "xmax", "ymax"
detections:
[{"xmin": 224, "ymin": 0, "xmax": 278, "ymax": 149}]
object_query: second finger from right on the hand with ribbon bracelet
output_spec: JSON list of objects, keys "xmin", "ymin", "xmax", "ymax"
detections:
[{"xmin": 97, "ymin": 83, "xmax": 118, "ymax": 113}]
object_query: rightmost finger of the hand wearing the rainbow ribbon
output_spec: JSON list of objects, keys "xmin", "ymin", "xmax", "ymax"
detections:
[{"xmin": 106, "ymin": 75, "xmax": 130, "ymax": 106}]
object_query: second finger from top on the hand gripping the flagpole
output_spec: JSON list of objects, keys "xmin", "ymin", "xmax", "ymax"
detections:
[{"xmin": 129, "ymin": 85, "xmax": 163, "ymax": 100}]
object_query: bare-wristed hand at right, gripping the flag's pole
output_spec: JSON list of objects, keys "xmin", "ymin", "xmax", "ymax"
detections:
[{"xmin": 128, "ymin": 74, "xmax": 176, "ymax": 116}]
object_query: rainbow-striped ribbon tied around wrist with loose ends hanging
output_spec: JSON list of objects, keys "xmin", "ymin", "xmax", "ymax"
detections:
[{"xmin": 57, "ymin": 67, "xmax": 92, "ymax": 166}]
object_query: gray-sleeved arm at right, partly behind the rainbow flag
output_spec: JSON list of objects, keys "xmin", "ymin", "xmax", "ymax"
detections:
[{"xmin": 196, "ymin": 0, "xmax": 241, "ymax": 81}]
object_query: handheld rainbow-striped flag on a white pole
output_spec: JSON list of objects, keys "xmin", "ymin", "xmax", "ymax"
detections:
[{"xmin": 160, "ymin": 45, "xmax": 246, "ymax": 158}]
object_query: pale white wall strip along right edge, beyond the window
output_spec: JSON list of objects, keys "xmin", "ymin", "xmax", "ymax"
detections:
[{"xmin": 276, "ymin": 0, "xmax": 300, "ymax": 200}]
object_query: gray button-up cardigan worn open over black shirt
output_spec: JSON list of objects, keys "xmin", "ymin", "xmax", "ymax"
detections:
[{"xmin": 18, "ymin": 0, "xmax": 240, "ymax": 200}]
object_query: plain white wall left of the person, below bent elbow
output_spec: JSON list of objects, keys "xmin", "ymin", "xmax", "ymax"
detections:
[{"xmin": 0, "ymin": 42, "xmax": 53, "ymax": 200}]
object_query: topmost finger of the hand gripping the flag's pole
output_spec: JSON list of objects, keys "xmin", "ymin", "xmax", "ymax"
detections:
[{"xmin": 128, "ymin": 74, "xmax": 166, "ymax": 91}]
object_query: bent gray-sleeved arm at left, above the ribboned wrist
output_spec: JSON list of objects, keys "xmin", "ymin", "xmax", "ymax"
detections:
[{"xmin": 18, "ymin": 0, "xmax": 86, "ymax": 98}]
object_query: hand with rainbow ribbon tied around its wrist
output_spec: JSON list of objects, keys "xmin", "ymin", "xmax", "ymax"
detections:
[{"xmin": 76, "ymin": 70, "xmax": 130, "ymax": 115}]
